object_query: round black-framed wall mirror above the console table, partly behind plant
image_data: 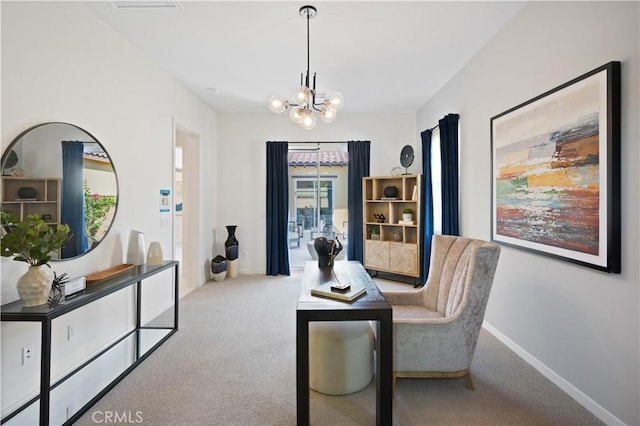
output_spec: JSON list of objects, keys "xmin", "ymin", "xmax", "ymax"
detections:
[{"xmin": 1, "ymin": 123, "xmax": 118, "ymax": 260}]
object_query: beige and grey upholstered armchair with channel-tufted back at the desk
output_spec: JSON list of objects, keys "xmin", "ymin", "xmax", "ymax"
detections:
[{"xmin": 384, "ymin": 235, "xmax": 500, "ymax": 390}]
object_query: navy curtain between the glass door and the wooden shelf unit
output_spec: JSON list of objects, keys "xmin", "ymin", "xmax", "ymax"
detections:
[{"xmin": 347, "ymin": 141, "xmax": 371, "ymax": 263}]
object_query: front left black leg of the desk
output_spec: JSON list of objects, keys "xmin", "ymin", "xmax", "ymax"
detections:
[{"xmin": 296, "ymin": 311, "xmax": 310, "ymax": 426}]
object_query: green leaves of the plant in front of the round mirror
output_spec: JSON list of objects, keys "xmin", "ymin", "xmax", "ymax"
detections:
[{"xmin": 0, "ymin": 211, "xmax": 71, "ymax": 266}]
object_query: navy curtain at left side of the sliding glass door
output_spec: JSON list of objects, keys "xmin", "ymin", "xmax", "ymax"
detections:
[{"xmin": 266, "ymin": 142, "xmax": 290, "ymax": 275}]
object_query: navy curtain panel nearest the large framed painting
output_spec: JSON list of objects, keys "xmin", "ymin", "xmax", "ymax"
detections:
[{"xmin": 438, "ymin": 114, "xmax": 460, "ymax": 235}]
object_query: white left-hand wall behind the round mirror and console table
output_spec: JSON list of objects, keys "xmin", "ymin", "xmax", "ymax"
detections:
[{"xmin": 0, "ymin": 2, "xmax": 218, "ymax": 422}]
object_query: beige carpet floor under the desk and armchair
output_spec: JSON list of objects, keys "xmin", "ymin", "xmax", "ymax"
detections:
[{"xmin": 76, "ymin": 271, "xmax": 602, "ymax": 426}]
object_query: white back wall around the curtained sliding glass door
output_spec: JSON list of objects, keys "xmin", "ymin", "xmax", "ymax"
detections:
[{"xmin": 218, "ymin": 111, "xmax": 421, "ymax": 274}]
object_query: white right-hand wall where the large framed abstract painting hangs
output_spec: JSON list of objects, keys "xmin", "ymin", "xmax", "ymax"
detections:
[{"xmin": 418, "ymin": 2, "xmax": 640, "ymax": 425}]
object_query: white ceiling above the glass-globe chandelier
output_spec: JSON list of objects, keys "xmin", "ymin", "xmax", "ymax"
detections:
[{"xmin": 84, "ymin": 0, "xmax": 524, "ymax": 112}]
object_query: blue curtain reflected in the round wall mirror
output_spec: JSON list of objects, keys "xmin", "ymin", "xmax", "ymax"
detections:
[{"xmin": 60, "ymin": 141, "xmax": 87, "ymax": 259}]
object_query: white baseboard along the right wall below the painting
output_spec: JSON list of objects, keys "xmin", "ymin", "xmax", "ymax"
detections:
[{"xmin": 482, "ymin": 321, "xmax": 624, "ymax": 425}]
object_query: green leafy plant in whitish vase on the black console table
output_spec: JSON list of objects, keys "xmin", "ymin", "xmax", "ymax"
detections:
[{"xmin": 0, "ymin": 212, "xmax": 71, "ymax": 307}]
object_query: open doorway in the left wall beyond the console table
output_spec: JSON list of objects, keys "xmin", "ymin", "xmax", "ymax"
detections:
[{"xmin": 173, "ymin": 125, "xmax": 200, "ymax": 297}]
